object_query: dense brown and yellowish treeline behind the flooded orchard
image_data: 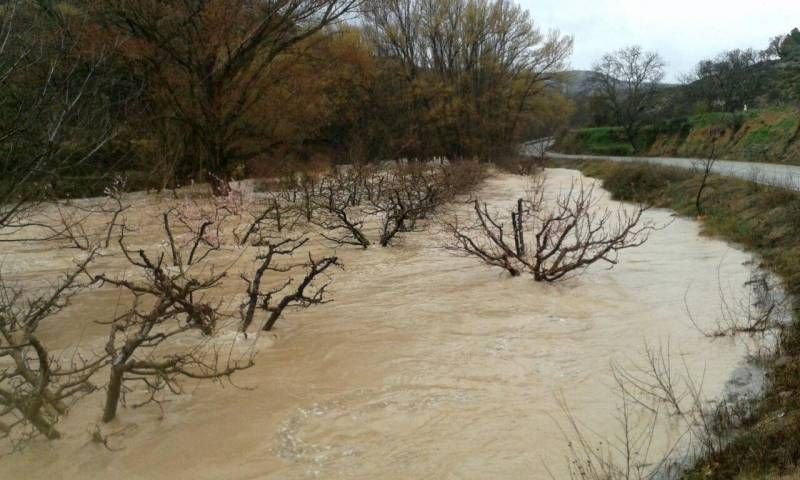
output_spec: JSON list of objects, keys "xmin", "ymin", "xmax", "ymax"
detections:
[{"xmin": 0, "ymin": 0, "xmax": 572, "ymax": 197}]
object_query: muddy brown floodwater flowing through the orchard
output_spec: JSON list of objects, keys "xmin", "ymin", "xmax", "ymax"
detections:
[{"xmin": 0, "ymin": 170, "xmax": 764, "ymax": 480}]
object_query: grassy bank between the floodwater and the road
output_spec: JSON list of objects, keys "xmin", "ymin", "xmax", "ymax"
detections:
[{"xmin": 552, "ymin": 158, "xmax": 800, "ymax": 479}]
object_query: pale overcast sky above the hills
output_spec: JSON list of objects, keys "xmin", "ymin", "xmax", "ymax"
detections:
[{"xmin": 518, "ymin": 0, "xmax": 800, "ymax": 81}]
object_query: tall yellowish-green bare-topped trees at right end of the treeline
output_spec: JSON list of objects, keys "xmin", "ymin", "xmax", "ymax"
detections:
[{"xmin": 365, "ymin": 0, "xmax": 572, "ymax": 159}]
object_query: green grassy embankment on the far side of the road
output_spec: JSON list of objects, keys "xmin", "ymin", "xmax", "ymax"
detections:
[{"xmin": 556, "ymin": 109, "xmax": 800, "ymax": 165}]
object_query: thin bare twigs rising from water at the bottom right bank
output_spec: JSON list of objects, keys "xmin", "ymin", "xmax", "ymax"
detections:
[{"xmin": 561, "ymin": 334, "xmax": 756, "ymax": 480}]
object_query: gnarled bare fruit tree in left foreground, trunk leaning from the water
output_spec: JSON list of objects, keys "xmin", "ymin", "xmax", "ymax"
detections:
[{"xmin": 96, "ymin": 212, "xmax": 253, "ymax": 422}]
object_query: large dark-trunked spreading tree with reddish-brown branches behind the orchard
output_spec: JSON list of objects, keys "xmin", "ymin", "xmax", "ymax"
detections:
[{"xmin": 90, "ymin": 0, "xmax": 360, "ymax": 193}]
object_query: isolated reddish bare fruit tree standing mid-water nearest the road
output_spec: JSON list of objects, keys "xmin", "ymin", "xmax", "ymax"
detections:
[{"xmin": 445, "ymin": 178, "xmax": 655, "ymax": 282}]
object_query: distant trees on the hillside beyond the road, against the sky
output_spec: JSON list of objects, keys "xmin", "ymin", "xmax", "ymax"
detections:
[{"xmin": 571, "ymin": 29, "xmax": 800, "ymax": 134}]
